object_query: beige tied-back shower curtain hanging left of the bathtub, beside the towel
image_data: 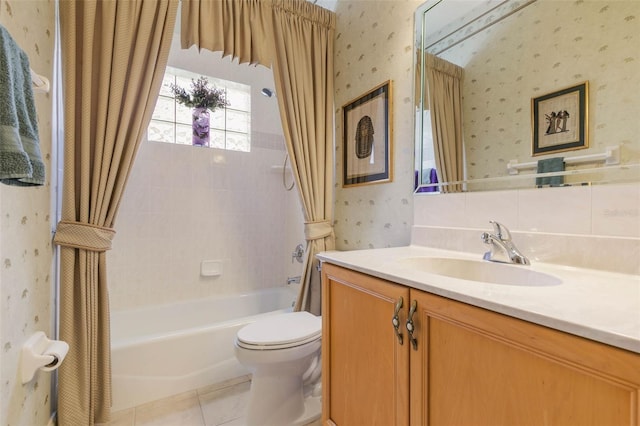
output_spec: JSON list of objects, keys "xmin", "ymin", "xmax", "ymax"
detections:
[{"xmin": 54, "ymin": 0, "xmax": 178, "ymax": 426}]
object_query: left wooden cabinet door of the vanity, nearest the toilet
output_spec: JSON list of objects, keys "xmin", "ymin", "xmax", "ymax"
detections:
[{"xmin": 322, "ymin": 263, "xmax": 409, "ymax": 426}]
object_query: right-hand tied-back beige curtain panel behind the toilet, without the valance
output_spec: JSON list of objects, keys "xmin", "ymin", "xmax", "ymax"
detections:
[{"xmin": 273, "ymin": 0, "xmax": 335, "ymax": 315}]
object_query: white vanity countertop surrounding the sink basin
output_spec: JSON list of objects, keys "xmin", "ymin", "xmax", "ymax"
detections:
[{"xmin": 318, "ymin": 246, "xmax": 640, "ymax": 353}]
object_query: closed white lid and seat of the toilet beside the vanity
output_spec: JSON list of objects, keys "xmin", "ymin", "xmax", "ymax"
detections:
[{"xmin": 236, "ymin": 311, "xmax": 322, "ymax": 349}]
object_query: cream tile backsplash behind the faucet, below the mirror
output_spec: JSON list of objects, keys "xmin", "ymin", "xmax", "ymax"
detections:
[{"xmin": 412, "ymin": 183, "xmax": 640, "ymax": 274}]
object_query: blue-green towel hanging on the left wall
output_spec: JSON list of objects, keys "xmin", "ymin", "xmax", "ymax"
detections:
[{"xmin": 0, "ymin": 26, "xmax": 45, "ymax": 186}]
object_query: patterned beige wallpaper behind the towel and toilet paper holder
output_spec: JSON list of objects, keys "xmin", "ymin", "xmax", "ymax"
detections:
[{"xmin": 0, "ymin": 0, "xmax": 55, "ymax": 426}]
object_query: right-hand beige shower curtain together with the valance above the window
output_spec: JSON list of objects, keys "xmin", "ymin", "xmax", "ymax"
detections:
[{"xmin": 182, "ymin": 0, "xmax": 335, "ymax": 314}]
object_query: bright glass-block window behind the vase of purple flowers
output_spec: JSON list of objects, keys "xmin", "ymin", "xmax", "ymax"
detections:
[{"xmin": 147, "ymin": 67, "xmax": 251, "ymax": 152}]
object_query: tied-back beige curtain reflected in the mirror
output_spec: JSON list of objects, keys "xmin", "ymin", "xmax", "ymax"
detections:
[{"xmin": 425, "ymin": 53, "xmax": 464, "ymax": 192}]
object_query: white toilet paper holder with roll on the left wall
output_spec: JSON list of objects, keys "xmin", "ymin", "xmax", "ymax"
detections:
[{"xmin": 20, "ymin": 331, "xmax": 69, "ymax": 384}]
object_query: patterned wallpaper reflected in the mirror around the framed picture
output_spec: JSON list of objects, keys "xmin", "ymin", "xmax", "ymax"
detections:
[{"xmin": 440, "ymin": 0, "xmax": 640, "ymax": 179}]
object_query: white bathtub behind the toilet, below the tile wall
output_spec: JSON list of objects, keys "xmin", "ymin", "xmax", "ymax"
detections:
[{"xmin": 111, "ymin": 287, "xmax": 297, "ymax": 411}]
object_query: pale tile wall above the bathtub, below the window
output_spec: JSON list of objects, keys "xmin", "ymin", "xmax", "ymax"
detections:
[{"xmin": 108, "ymin": 132, "xmax": 304, "ymax": 310}]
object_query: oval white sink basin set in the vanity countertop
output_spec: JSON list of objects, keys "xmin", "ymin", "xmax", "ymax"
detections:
[{"xmin": 400, "ymin": 257, "xmax": 562, "ymax": 287}]
